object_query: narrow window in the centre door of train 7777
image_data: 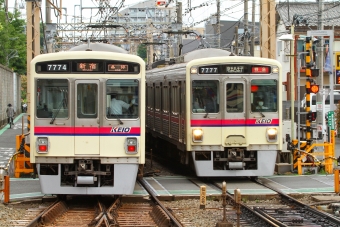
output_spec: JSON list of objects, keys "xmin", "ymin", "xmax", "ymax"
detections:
[{"xmin": 226, "ymin": 83, "xmax": 244, "ymax": 113}]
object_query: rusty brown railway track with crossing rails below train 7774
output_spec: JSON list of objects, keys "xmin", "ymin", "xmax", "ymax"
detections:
[{"xmin": 13, "ymin": 196, "xmax": 167, "ymax": 227}]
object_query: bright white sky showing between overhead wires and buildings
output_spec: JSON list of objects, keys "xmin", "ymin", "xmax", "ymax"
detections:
[{"xmin": 9, "ymin": 0, "xmax": 259, "ymax": 27}]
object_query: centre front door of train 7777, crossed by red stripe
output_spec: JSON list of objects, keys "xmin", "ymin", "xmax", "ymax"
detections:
[{"xmin": 222, "ymin": 79, "xmax": 246, "ymax": 143}]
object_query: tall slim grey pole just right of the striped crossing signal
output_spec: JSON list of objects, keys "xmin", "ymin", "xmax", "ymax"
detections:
[{"xmin": 316, "ymin": 0, "xmax": 327, "ymax": 137}]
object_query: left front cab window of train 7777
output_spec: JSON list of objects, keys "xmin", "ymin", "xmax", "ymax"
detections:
[{"xmin": 191, "ymin": 80, "xmax": 220, "ymax": 113}]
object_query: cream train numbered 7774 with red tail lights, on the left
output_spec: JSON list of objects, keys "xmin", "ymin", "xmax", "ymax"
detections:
[{"xmin": 30, "ymin": 44, "xmax": 145, "ymax": 195}]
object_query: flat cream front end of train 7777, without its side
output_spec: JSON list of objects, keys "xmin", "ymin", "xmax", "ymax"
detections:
[{"xmin": 186, "ymin": 56, "xmax": 282, "ymax": 177}]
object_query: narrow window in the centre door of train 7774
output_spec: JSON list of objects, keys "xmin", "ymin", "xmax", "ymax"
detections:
[{"xmin": 77, "ymin": 83, "xmax": 98, "ymax": 118}]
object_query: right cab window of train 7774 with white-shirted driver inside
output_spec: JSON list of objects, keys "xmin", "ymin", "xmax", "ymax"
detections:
[{"xmin": 106, "ymin": 79, "xmax": 139, "ymax": 119}]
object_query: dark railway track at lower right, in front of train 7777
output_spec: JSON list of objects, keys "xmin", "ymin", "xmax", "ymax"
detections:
[{"xmin": 210, "ymin": 181, "xmax": 340, "ymax": 227}]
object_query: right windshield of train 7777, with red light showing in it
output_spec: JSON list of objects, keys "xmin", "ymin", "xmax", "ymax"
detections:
[{"xmin": 251, "ymin": 80, "xmax": 278, "ymax": 112}]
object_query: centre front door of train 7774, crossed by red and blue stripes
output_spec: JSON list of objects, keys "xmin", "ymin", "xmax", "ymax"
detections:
[{"xmin": 74, "ymin": 80, "xmax": 99, "ymax": 155}]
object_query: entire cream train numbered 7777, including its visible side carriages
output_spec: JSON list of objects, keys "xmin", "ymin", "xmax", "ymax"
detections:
[{"xmin": 146, "ymin": 49, "xmax": 282, "ymax": 177}]
